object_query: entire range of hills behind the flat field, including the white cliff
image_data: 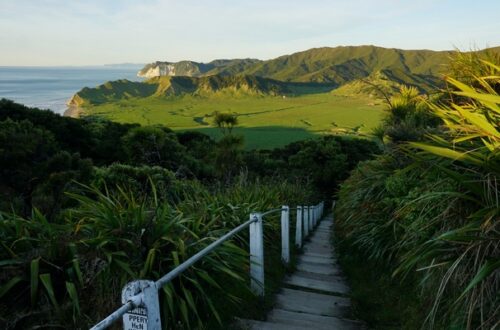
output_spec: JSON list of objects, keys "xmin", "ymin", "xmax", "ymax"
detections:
[{"xmin": 68, "ymin": 46, "xmax": 500, "ymax": 106}]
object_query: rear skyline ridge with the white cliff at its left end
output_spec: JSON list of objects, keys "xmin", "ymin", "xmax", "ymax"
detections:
[{"xmin": 139, "ymin": 46, "xmax": 500, "ymax": 92}]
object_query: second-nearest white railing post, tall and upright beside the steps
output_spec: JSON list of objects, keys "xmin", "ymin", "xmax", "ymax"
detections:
[{"xmin": 249, "ymin": 213, "xmax": 264, "ymax": 296}]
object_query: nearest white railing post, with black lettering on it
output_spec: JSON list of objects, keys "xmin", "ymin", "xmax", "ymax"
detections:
[{"xmin": 122, "ymin": 280, "xmax": 161, "ymax": 330}]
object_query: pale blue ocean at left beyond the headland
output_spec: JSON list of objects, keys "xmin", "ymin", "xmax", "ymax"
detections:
[{"xmin": 0, "ymin": 65, "xmax": 142, "ymax": 115}]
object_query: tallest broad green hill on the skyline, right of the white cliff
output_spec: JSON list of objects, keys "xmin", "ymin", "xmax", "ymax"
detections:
[{"xmin": 236, "ymin": 46, "xmax": 452, "ymax": 85}]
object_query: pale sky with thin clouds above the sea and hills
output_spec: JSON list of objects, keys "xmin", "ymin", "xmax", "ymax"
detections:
[{"xmin": 0, "ymin": 0, "xmax": 500, "ymax": 66}]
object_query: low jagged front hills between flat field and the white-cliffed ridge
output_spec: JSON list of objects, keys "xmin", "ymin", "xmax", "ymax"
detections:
[{"xmin": 68, "ymin": 75, "xmax": 292, "ymax": 106}]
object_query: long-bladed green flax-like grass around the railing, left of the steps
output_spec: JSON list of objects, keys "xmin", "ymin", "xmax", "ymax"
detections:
[{"xmin": 0, "ymin": 178, "xmax": 310, "ymax": 329}]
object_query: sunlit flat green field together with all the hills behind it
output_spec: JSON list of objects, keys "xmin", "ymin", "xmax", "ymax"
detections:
[{"xmin": 68, "ymin": 46, "xmax": 499, "ymax": 149}]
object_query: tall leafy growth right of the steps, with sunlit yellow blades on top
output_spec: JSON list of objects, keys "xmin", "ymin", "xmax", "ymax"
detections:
[{"xmin": 337, "ymin": 51, "xmax": 500, "ymax": 329}]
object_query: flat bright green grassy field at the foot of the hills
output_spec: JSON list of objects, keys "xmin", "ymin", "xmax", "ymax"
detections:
[{"xmin": 81, "ymin": 93, "xmax": 384, "ymax": 148}]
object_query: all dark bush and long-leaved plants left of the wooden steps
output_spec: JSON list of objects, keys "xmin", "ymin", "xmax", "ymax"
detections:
[{"xmin": 0, "ymin": 100, "xmax": 377, "ymax": 329}]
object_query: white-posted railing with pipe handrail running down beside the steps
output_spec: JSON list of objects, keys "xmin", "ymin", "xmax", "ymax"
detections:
[{"xmin": 91, "ymin": 202, "xmax": 324, "ymax": 330}]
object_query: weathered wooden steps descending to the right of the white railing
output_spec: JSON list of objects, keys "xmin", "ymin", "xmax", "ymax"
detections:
[{"xmin": 241, "ymin": 214, "xmax": 364, "ymax": 330}]
